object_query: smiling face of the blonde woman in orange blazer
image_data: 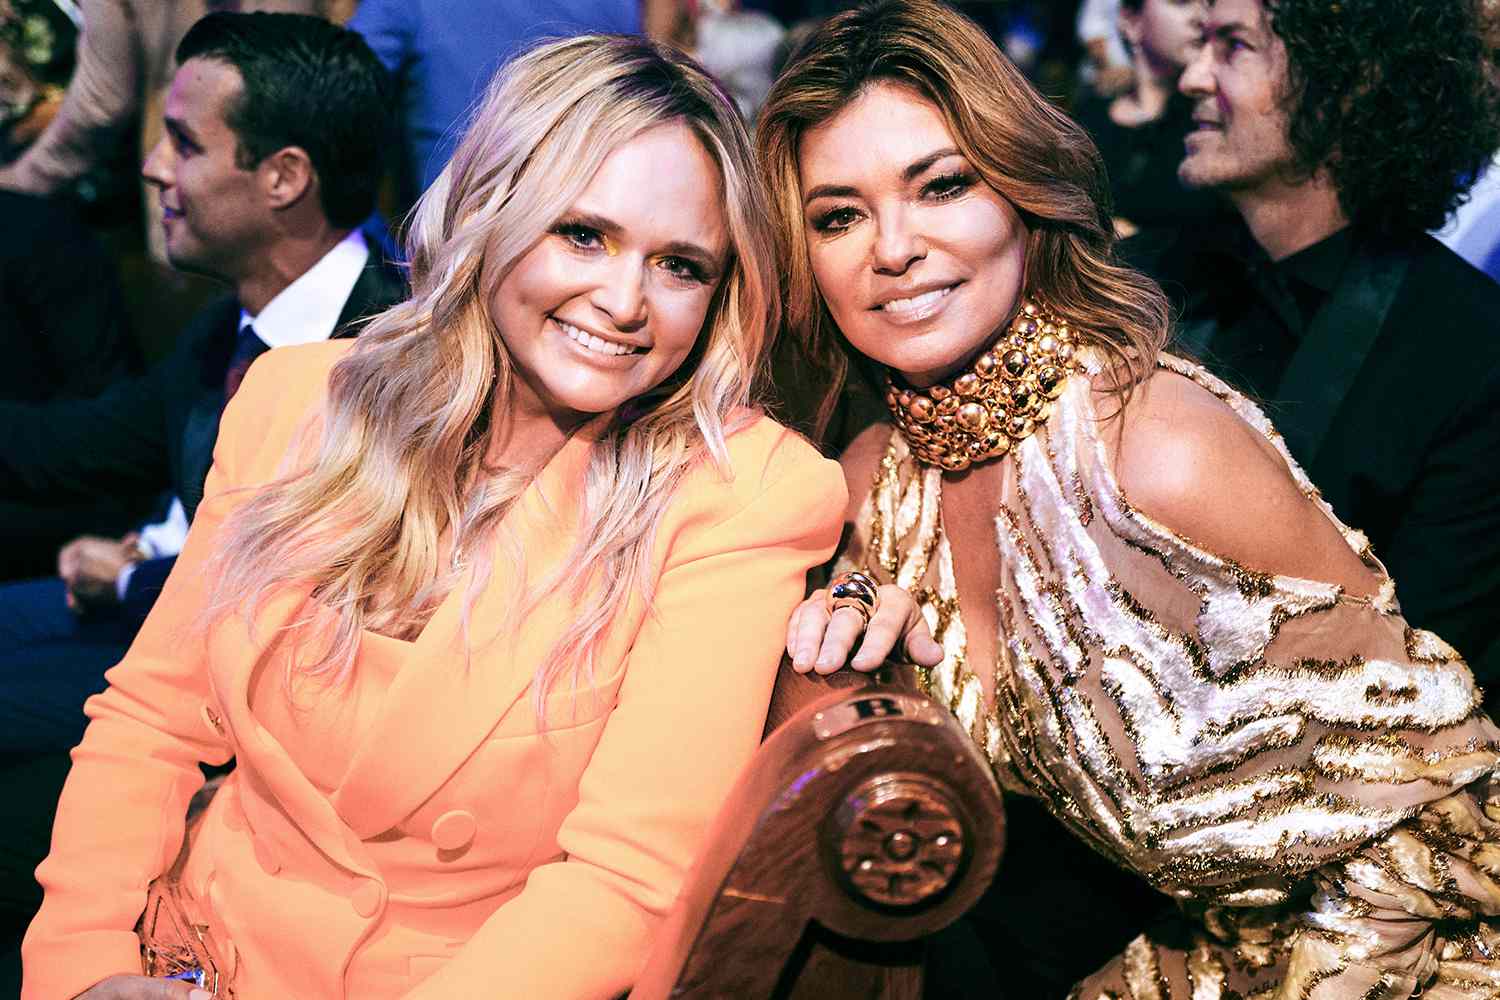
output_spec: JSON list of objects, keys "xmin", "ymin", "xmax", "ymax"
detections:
[{"xmin": 489, "ymin": 124, "xmax": 729, "ymax": 426}]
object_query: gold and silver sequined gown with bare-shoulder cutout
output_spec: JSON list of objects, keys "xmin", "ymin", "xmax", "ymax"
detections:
[{"xmin": 860, "ymin": 357, "xmax": 1500, "ymax": 1000}]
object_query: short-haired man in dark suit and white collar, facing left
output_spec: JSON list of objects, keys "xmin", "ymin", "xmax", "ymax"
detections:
[{"xmin": 0, "ymin": 13, "xmax": 402, "ymax": 983}]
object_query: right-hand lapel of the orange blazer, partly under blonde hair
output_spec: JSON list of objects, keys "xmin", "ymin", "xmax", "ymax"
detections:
[{"xmin": 333, "ymin": 435, "xmax": 591, "ymax": 838}]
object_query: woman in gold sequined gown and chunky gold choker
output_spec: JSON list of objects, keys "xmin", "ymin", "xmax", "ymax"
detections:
[{"xmin": 756, "ymin": 0, "xmax": 1500, "ymax": 1000}]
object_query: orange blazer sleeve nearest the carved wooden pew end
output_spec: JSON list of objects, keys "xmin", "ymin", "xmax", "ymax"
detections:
[{"xmin": 408, "ymin": 433, "xmax": 846, "ymax": 1000}]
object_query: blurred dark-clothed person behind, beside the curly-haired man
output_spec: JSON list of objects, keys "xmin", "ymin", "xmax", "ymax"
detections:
[{"xmin": 1073, "ymin": 0, "xmax": 1227, "ymax": 235}]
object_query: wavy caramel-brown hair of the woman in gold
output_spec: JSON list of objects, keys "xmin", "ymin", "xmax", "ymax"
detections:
[{"xmin": 756, "ymin": 0, "xmax": 1169, "ymax": 435}]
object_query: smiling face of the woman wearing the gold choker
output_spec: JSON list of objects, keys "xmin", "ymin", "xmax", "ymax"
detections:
[{"xmin": 798, "ymin": 82, "xmax": 1029, "ymax": 385}]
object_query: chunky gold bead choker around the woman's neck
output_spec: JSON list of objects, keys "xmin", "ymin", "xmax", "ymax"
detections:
[{"xmin": 885, "ymin": 301, "xmax": 1079, "ymax": 472}]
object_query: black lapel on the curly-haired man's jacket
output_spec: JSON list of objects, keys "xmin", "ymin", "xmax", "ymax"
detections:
[{"xmin": 1275, "ymin": 249, "xmax": 1409, "ymax": 466}]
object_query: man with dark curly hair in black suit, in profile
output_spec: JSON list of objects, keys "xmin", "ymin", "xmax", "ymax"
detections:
[{"xmin": 1127, "ymin": 0, "xmax": 1500, "ymax": 694}]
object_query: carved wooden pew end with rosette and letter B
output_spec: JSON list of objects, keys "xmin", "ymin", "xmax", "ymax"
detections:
[{"xmin": 630, "ymin": 664, "xmax": 1005, "ymax": 1000}]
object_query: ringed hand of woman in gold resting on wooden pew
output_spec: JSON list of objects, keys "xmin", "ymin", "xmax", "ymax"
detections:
[{"xmin": 786, "ymin": 583, "xmax": 942, "ymax": 673}]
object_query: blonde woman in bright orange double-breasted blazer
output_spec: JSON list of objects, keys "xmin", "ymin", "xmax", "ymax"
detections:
[{"xmin": 24, "ymin": 31, "xmax": 845, "ymax": 1000}]
